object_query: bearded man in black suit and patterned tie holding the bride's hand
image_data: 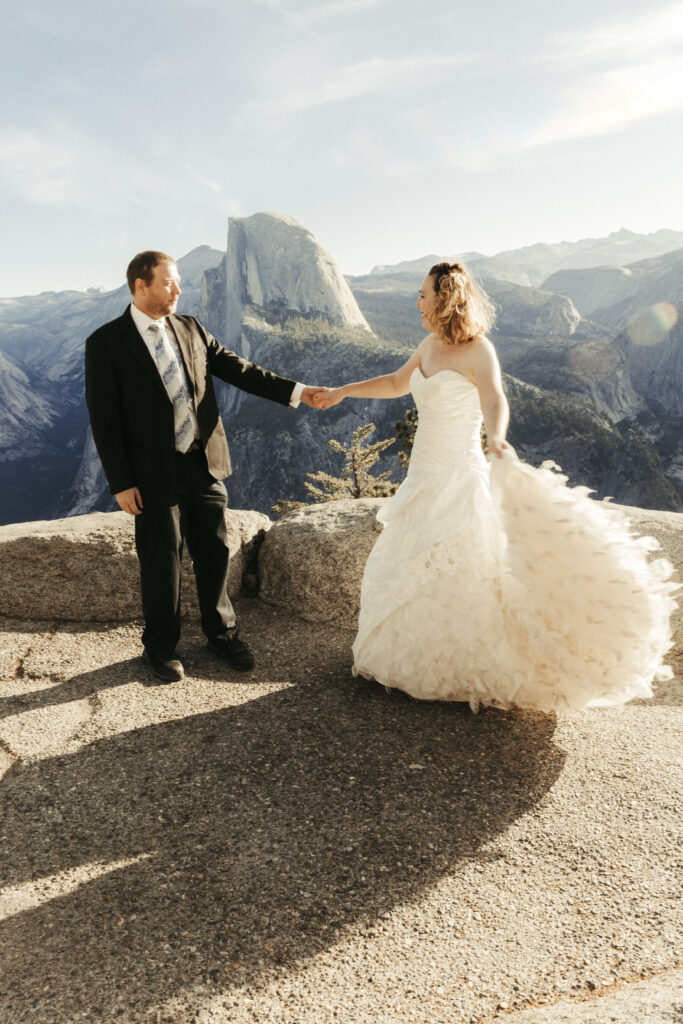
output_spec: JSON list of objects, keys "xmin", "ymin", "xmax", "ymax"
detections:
[{"xmin": 85, "ymin": 251, "xmax": 326, "ymax": 683}]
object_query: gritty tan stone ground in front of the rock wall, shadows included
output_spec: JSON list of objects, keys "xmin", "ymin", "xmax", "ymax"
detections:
[{"xmin": 0, "ymin": 601, "xmax": 683, "ymax": 1024}]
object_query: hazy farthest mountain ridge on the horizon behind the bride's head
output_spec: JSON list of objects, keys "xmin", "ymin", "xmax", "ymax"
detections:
[{"xmin": 371, "ymin": 227, "xmax": 683, "ymax": 286}]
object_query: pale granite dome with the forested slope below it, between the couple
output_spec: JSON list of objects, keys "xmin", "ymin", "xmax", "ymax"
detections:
[{"xmin": 189, "ymin": 213, "xmax": 409, "ymax": 511}]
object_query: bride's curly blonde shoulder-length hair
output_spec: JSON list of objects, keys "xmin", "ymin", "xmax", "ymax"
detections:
[{"xmin": 429, "ymin": 263, "xmax": 496, "ymax": 345}]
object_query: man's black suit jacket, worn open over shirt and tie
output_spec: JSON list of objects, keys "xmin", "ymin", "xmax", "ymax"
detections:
[{"xmin": 85, "ymin": 306, "xmax": 295, "ymax": 503}]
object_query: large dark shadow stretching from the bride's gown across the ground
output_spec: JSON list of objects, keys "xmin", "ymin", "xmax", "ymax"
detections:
[{"xmin": 0, "ymin": 681, "xmax": 564, "ymax": 1024}]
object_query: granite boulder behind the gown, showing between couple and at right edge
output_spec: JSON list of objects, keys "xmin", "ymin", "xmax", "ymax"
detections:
[{"xmin": 258, "ymin": 498, "xmax": 683, "ymax": 626}]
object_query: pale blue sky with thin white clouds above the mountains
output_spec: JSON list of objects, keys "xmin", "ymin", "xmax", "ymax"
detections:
[{"xmin": 0, "ymin": 0, "xmax": 683, "ymax": 296}]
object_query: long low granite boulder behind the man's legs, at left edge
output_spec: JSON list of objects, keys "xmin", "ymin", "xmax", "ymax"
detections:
[{"xmin": 0, "ymin": 510, "xmax": 270, "ymax": 622}]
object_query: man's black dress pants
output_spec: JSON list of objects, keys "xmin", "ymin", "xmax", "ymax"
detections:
[{"xmin": 135, "ymin": 450, "xmax": 236, "ymax": 656}]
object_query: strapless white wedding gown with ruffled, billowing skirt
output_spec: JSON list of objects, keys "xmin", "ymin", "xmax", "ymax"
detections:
[{"xmin": 353, "ymin": 370, "xmax": 677, "ymax": 711}]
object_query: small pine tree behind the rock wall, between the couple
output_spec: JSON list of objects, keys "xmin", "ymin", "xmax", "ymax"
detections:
[{"xmin": 270, "ymin": 423, "xmax": 398, "ymax": 515}]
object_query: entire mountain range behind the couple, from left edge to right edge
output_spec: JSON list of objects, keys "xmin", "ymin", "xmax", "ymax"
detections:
[{"xmin": 0, "ymin": 220, "xmax": 683, "ymax": 522}]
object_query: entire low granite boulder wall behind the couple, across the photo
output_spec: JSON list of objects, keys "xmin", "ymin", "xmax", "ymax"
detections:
[{"xmin": 0, "ymin": 498, "xmax": 683, "ymax": 651}]
